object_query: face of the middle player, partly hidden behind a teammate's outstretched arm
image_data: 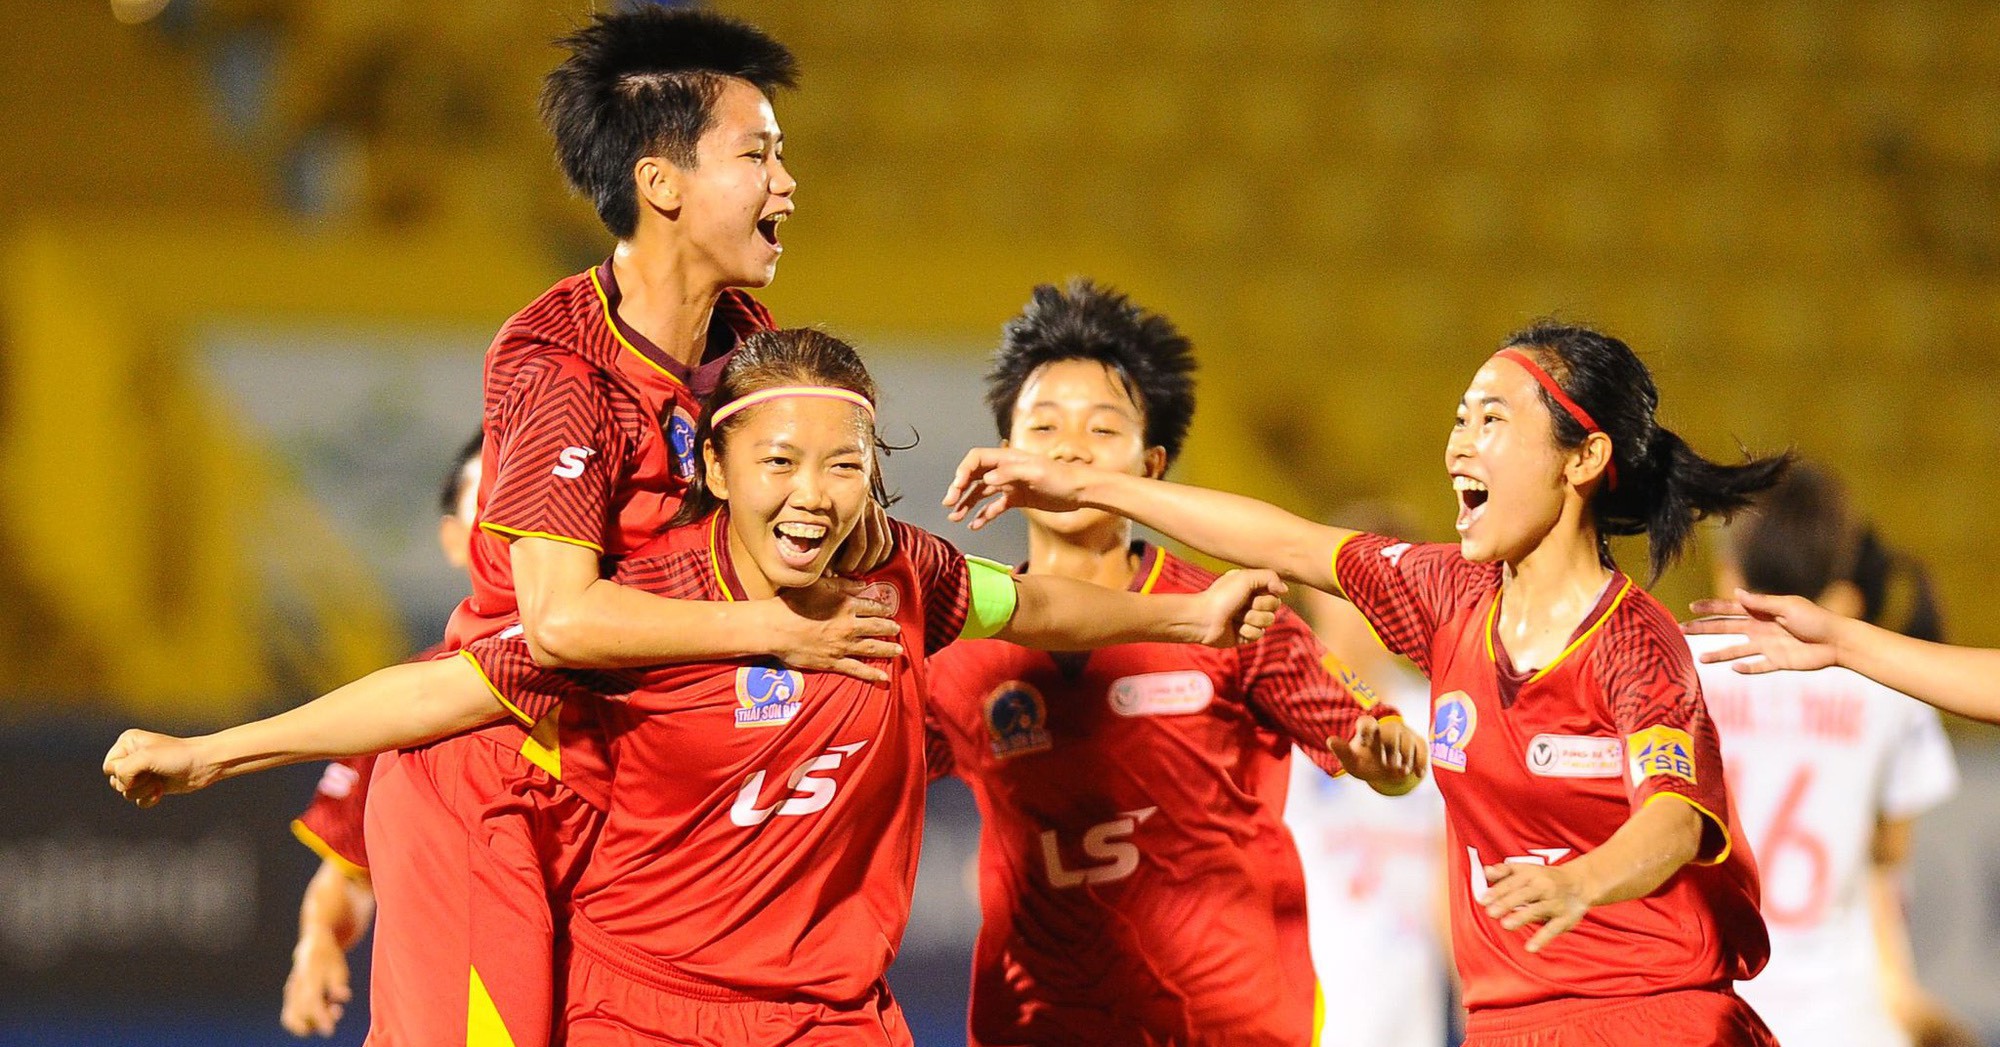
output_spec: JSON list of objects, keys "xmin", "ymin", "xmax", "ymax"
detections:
[{"xmin": 1006, "ymin": 360, "xmax": 1166, "ymax": 533}]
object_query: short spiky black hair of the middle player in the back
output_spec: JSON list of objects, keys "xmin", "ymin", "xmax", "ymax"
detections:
[{"xmin": 986, "ymin": 278, "xmax": 1194, "ymax": 462}]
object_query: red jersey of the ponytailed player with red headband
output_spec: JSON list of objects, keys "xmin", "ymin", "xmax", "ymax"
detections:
[{"xmin": 1334, "ymin": 533, "xmax": 1770, "ymax": 1011}]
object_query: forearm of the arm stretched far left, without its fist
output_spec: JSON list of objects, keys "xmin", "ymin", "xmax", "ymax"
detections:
[{"xmin": 192, "ymin": 657, "xmax": 506, "ymax": 783}]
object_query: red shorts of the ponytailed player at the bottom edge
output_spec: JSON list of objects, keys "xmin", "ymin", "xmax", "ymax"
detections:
[{"xmin": 1464, "ymin": 989, "xmax": 1778, "ymax": 1047}]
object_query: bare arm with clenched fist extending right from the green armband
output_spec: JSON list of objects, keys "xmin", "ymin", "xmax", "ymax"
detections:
[{"xmin": 994, "ymin": 571, "xmax": 1284, "ymax": 651}]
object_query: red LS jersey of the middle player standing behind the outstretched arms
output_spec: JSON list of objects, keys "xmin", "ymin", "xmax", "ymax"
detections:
[{"xmin": 930, "ymin": 543, "xmax": 1394, "ymax": 1045}]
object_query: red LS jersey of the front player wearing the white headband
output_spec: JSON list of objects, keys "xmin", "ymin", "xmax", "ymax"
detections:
[{"xmin": 466, "ymin": 514, "xmax": 970, "ymax": 1003}]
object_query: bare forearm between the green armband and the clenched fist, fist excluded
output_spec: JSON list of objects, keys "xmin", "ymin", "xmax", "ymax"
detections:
[{"xmin": 994, "ymin": 575, "xmax": 1200, "ymax": 651}]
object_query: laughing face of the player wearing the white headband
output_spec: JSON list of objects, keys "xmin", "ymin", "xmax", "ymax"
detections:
[{"xmin": 702, "ymin": 396, "xmax": 874, "ymax": 597}]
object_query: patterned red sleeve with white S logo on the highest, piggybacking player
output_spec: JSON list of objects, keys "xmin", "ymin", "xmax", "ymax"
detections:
[{"xmin": 480, "ymin": 352, "xmax": 632, "ymax": 553}]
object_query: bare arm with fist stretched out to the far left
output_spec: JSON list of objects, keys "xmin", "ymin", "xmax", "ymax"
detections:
[{"xmin": 104, "ymin": 657, "xmax": 508, "ymax": 807}]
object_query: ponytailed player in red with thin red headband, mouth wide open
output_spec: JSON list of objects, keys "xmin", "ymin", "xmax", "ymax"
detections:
[{"xmin": 946, "ymin": 324, "xmax": 1788, "ymax": 1047}]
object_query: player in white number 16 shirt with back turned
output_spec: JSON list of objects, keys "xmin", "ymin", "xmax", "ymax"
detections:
[{"xmin": 1690, "ymin": 466, "xmax": 1970, "ymax": 1047}]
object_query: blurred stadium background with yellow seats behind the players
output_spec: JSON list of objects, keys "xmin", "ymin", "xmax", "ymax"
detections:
[{"xmin": 0, "ymin": 0, "xmax": 2000, "ymax": 1045}]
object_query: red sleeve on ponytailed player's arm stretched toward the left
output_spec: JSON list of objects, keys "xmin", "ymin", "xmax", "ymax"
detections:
[{"xmin": 1334, "ymin": 533, "xmax": 1500, "ymax": 675}]
